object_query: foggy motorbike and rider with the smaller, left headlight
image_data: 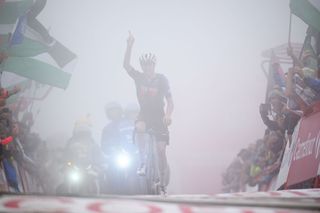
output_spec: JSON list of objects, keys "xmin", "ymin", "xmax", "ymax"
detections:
[{"xmin": 56, "ymin": 115, "xmax": 104, "ymax": 195}]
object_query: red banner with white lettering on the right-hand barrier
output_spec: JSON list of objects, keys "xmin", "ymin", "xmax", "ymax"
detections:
[{"xmin": 287, "ymin": 112, "xmax": 320, "ymax": 186}]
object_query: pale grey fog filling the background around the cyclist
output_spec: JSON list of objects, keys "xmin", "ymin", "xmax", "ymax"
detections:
[{"xmin": 31, "ymin": 0, "xmax": 306, "ymax": 194}]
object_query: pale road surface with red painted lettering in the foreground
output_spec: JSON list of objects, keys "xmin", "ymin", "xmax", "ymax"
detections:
[{"xmin": 0, "ymin": 189, "xmax": 320, "ymax": 213}]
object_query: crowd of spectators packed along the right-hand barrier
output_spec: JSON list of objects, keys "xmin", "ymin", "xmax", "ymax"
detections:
[{"xmin": 222, "ymin": 27, "xmax": 320, "ymax": 192}]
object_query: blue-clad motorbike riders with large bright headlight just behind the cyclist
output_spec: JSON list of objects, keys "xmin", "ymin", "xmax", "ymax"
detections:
[{"xmin": 101, "ymin": 102, "xmax": 139, "ymax": 194}]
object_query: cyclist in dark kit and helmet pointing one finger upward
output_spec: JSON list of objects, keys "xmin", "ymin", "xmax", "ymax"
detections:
[{"xmin": 123, "ymin": 33, "xmax": 173, "ymax": 194}]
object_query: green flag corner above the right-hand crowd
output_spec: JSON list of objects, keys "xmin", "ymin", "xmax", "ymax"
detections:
[{"xmin": 290, "ymin": 0, "xmax": 320, "ymax": 32}]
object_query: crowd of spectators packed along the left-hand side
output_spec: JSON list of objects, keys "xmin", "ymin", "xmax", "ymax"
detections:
[{"xmin": 0, "ymin": 54, "xmax": 47, "ymax": 192}]
